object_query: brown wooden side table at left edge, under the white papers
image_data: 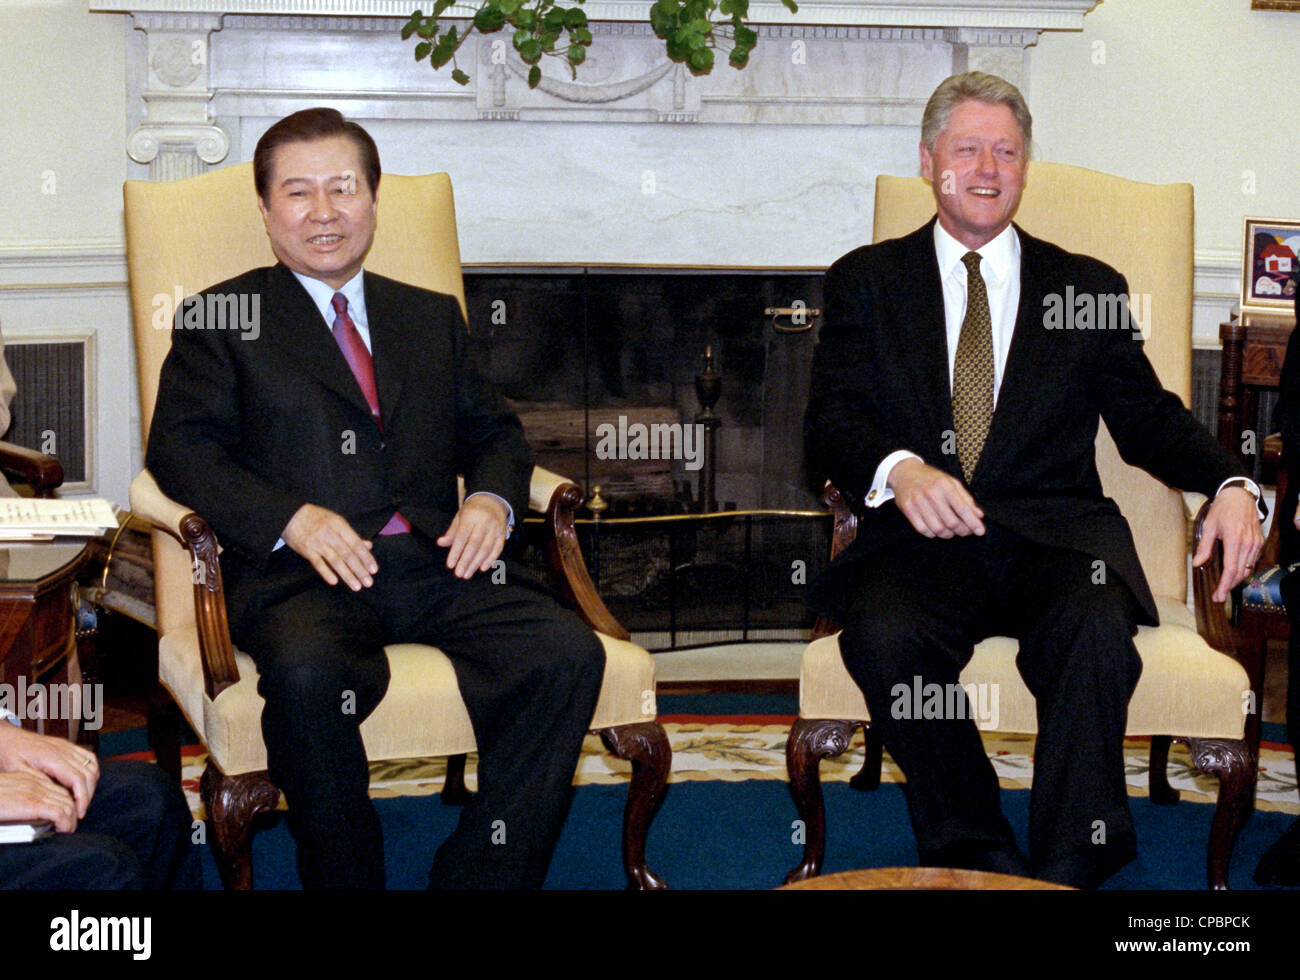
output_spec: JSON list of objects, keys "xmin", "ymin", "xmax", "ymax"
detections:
[{"xmin": 0, "ymin": 541, "xmax": 91, "ymax": 738}]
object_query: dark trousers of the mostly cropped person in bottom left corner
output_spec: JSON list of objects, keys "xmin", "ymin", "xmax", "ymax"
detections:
[{"xmin": 0, "ymin": 753, "xmax": 200, "ymax": 890}]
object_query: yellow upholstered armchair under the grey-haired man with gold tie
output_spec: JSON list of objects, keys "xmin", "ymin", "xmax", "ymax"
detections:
[{"xmin": 787, "ymin": 164, "xmax": 1256, "ymax": 888}]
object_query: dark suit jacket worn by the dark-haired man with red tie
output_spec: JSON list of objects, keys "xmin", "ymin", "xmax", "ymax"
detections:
[{"xmin": 146, "ymin": 265, "xmax": 532, "ymax": 625}]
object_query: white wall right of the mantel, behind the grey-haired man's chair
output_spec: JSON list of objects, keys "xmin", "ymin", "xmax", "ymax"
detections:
[{"xmin": 1026, "ymin": 0, "xmax": 1300, "ymax": 346}]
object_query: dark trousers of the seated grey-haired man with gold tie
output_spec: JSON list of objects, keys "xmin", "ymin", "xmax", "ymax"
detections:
[{"xmin": 840, "ymin": 525, "xmax": 1141, "ymax": 886}]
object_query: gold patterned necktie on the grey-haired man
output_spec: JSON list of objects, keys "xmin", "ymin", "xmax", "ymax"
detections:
[{"xmin": 953, "ymin": 252, "xmax": 993, "ymax": 484}]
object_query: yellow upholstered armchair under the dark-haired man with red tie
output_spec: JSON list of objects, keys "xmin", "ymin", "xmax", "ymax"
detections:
[{"xmin": 124, "ymin": 164, "xmax": 671, "ymax": 888}]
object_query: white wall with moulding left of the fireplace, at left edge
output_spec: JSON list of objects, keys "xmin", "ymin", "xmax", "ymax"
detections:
[{"xmin": 0, "ymin": 0, "xmax": 140, "ymax": 504}]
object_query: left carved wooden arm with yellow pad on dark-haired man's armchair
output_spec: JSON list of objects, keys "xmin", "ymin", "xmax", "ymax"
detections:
[{"xmin": 130, "ymin": 469, "xmax": 239, "ymax": 698}]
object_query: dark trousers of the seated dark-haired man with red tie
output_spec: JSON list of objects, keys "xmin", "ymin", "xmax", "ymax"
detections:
[{"xmin": 237, "ymin": 532, "xmax": 605, "ymax": 888}]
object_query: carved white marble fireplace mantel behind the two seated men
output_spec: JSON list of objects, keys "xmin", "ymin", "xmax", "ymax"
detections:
[{"xmin": 91, "ymin": 0, "xmax": 1096, "ymax": 266}]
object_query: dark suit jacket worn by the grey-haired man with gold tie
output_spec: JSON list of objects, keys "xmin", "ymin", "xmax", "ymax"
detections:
[{"xmin": 805, "ymin": 221, "xmax": 1243, "ymax": 623}]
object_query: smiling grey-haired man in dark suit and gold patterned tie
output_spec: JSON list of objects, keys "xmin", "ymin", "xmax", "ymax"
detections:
[{"xmin": 805, "ymin": 73, "xmax": 1262, "ymax": 886}]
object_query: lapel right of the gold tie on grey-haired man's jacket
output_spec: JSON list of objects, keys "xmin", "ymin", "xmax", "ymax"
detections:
[{"xmin": 972, "ymin": 226, "xmax": 1052, "ymax": 480}]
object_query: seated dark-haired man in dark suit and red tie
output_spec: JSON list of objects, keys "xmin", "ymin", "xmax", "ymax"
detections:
[{"xmin": 147, "ymin": 109, "xmax": 605, "ymax": 888}]
